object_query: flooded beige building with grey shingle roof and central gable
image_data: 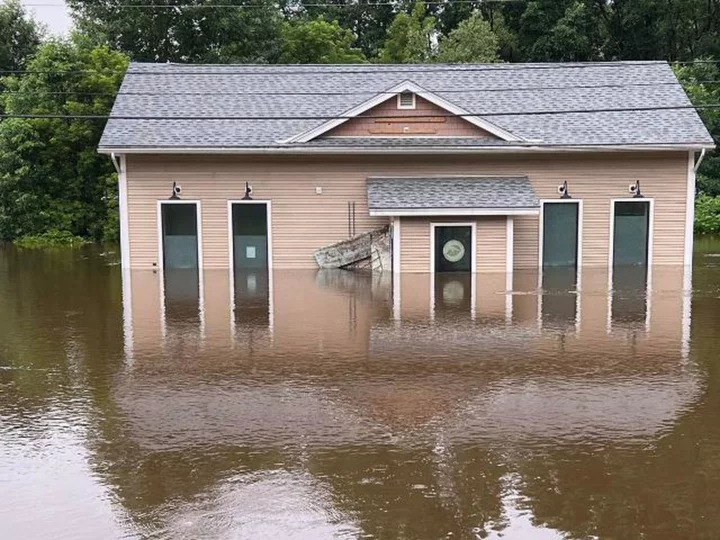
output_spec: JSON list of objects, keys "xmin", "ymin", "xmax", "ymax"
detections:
[{"xmin": 100, "ymin": 62, "xmax": 713, "ymax": 282}]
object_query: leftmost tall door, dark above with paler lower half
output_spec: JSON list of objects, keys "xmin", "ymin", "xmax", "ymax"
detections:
[{"xmin": 160, "ymin": 203, "xmax": 198, "ymax": 269}]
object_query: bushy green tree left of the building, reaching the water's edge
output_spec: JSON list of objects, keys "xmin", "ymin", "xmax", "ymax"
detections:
[{"xmin": 0, "ymin": 37, "xmax": 128, "ymax": 240}]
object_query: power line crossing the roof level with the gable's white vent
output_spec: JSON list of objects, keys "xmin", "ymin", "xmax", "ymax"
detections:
[{"xmin": 4, "ymin": 80, "xmax": 720, "ymax": 98}]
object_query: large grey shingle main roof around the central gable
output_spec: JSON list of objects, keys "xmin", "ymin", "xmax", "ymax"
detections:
[{"xmin": 100, "ymin": 62, "xmax": 712, "ymax": 150}]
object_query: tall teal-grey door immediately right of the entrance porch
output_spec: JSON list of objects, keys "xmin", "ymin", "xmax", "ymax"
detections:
[{"xmin": 543, "ymin": 202, "xmax": 580, "ymax": 269}]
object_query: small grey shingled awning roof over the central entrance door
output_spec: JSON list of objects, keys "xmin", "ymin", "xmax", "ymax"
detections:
[{"xmin": 367, "ymin": 176, "xmax": 540, "ymax": 216}]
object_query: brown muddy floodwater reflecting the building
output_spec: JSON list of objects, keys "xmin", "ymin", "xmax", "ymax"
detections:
[{"xmin": 0, "ymin": 240, "xmax": 720, "ymax": 540}]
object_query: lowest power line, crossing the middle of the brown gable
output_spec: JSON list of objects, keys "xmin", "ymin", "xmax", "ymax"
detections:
[{"xmin": 0, "ymin": 103, "xmax": 720, "ymax": 121}]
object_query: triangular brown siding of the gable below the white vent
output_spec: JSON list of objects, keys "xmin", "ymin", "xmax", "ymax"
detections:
[{"xmin": 323, "ymin": 96, "xmax": 497, "ymax": 139}]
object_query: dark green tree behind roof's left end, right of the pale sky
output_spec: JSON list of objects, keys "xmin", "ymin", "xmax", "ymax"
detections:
[{"xmin": 68, "ymin": 0, "xmax": 282, "ymax": 63}]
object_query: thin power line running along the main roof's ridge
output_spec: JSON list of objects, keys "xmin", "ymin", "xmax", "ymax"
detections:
[{"xmin": 0, "ymin": 60, "xmax": 720, "ymax": 77}]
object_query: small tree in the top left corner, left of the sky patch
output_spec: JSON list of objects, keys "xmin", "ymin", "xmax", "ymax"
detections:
[{"xmin": 0, "ymin": 0, "xmax": 43, "ymax": 71}]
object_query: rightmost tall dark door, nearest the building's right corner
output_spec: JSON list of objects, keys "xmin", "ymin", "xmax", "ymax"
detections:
[{"xmin": 613, "ymin": 201, "xmax": 650, "ymax": 268}]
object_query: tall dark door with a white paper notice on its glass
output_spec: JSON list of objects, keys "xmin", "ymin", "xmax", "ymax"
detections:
[{"xmin": 232, "ymin": 203, "xmax": 268, "ymax": 272}]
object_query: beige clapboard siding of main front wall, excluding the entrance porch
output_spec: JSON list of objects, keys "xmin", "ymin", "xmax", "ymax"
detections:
[{"xmin": 127, "ymin": 152, "xmax": 688, "ymax": 270}]
